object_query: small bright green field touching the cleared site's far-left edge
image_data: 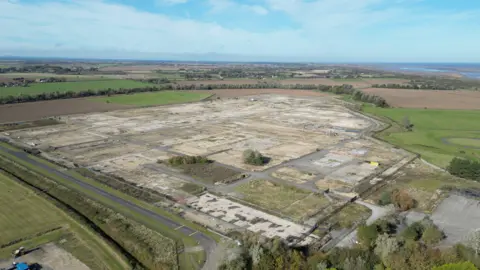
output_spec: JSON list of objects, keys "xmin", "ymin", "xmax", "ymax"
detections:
[{"xmin": 92, "ymin": 91, "xmax": 209, "ymax": 106}]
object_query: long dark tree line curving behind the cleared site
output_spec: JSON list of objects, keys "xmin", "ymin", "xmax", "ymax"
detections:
[{"xmin": 0, "ymin": 83, "xmax": 388, "ymax": 107}]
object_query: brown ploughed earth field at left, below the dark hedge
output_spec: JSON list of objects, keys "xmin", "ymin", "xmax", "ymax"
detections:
[{"xmin": 0, "ymin": 98, "xmax": 131, "ymax": 123}]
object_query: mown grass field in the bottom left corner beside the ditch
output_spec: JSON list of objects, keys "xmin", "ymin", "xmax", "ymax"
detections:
[{"xmin": 0, "ymin": 173, "xmax": 127, "ymax": 269}]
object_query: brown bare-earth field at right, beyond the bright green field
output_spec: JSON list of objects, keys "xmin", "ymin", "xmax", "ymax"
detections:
[{"xmin": 363, "ymin": 88, "xmax": 480, "ymax": 110}]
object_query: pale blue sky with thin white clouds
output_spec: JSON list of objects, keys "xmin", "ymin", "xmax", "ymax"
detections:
[{"xmin": 0, "ymin": 0, "xmax": 480, "ymax": 62}]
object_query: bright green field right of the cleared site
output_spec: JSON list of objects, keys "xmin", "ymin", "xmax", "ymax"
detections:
[{"xmin": 364, "ymin": 105, "xmax": 480, "ymax": 167}]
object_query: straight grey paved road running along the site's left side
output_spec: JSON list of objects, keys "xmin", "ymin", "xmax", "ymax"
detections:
[{"xmin": 0, "ymin": 146, "xmax": 216, "ymax": 270}]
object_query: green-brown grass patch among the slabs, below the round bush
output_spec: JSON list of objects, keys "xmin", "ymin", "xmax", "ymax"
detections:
[{"xmin": 235, "ymin": 180, "xmax": 329, "ymax": 219}]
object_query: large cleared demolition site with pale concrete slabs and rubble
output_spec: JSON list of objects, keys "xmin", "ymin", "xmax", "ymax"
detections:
[{"xmin": 1, "ymin": 95, "xmax": 413, "ymax": 245}]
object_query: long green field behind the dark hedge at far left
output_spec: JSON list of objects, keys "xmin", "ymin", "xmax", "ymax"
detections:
[{"xmin": 0, "ymin": 80, "xmax": 155, "ymax": 97}]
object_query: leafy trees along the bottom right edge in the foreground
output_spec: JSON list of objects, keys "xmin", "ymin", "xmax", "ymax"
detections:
[{"xmin": 219, "ymin": 213, "xmax": 480, "ymax": 270}]
